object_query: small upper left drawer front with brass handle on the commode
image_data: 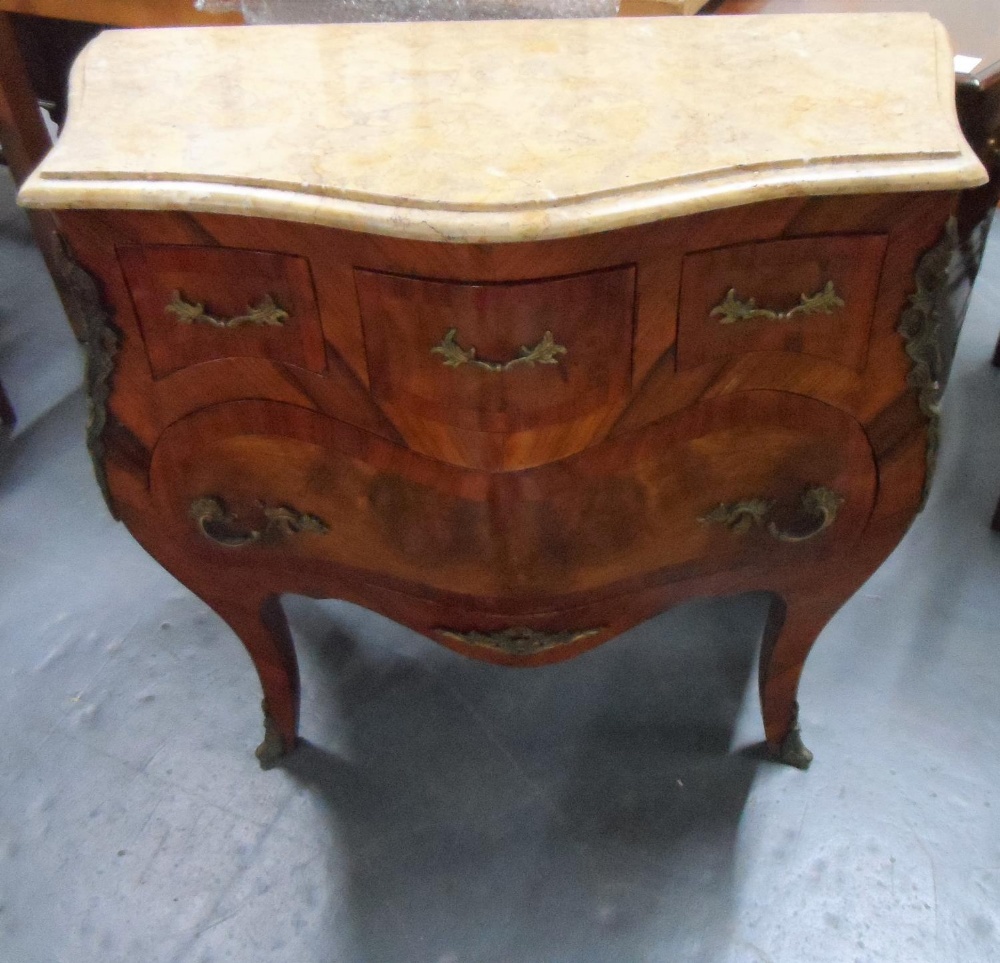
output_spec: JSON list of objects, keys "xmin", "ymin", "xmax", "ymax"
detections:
[{"xmin": 117, "ymin": 245, "xmax": 326, "ymax": 378}]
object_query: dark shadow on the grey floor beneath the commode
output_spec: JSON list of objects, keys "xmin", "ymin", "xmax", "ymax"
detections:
[{"xmin": 274, "ymin": 596, "xmax": 766, "ymax": 963}]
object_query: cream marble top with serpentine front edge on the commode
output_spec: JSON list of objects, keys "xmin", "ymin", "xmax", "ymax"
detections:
[{"xmin": 21, "ymin": 14, "xmax": 986, "ymax": 241}]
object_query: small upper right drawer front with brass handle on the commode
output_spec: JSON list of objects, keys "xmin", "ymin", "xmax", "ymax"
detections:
[{"xmin": 677, "ymin": 234, "xmax": 887, "ymax": 371}]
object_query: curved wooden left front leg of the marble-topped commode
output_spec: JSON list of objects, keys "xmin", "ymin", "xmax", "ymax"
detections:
[{"xmin": 198, "ymin": 593, "xmax": 300, "ymax": 769}]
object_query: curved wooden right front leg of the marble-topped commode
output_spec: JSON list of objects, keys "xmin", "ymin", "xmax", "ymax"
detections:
[{"xmin": 759, "ymin": 593, "xmax": 850, "ymax": 769}]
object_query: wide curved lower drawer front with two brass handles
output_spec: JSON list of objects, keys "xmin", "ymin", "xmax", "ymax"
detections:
[{"xmin": 152, "ymin": 391, "xmax": 875, "ymax": 611}]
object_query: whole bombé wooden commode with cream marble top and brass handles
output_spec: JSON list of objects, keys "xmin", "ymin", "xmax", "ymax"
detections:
[{"xmin": 21, "ymin": 15, "xmax": 986, "ymax": 766}]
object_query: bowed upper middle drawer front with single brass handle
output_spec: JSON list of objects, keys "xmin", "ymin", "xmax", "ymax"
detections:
[{"xmin": 355, "ymin": 267, "xmax": 635, "ymax": 432}]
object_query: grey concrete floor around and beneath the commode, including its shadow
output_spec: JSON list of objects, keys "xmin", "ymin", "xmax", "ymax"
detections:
[{"xmin": 0, "ymin": 166, "xmax": 1000, "ymax": 963}]
